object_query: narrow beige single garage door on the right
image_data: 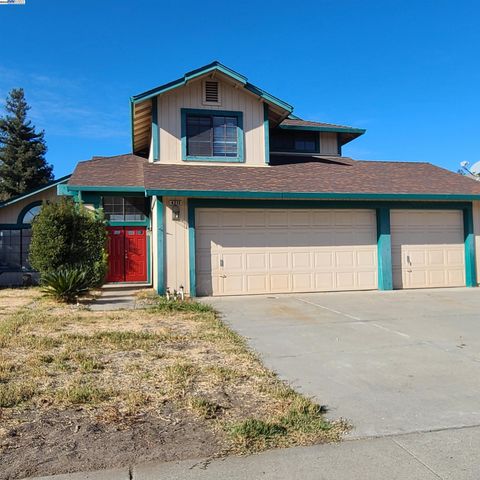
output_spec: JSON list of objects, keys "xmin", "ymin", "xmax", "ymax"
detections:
[{"xmin": 390, "ymin": 210, "xmax": 465, "ymax": 288}]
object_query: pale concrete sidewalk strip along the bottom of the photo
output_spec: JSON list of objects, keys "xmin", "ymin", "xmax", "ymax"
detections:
[{"xmin": 29, "ymin": 427, "xmax": 480, "ymax": 480}]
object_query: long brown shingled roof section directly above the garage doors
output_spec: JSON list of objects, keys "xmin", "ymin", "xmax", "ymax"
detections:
[{"xmin": 145, "ymin": 157, "xmax": 480, "ymax": 195}]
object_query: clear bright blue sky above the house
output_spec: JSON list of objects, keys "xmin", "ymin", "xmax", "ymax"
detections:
[{"xmin": 0, "ymin": 0, "xmax": 480, "ymax": 176}]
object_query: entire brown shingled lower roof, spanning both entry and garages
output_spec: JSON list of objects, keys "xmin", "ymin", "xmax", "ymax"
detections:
[{"xmin": 69, "ymin": 155, "xmax": 480, "ymax": 196}]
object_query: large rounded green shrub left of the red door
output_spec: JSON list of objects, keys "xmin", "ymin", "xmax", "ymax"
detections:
[{"xmin": 29, "ymin": 198, "xmax": 107, "ymax": 288}]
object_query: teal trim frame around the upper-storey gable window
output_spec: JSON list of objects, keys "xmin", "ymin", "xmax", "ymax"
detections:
[{"xmin": 181, "ymin": 108, "xmax": 245, "ymax": 163}]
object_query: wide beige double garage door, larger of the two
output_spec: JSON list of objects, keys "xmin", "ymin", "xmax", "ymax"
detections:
[{"xmin": 196, "ymin": 209, "xmax": 377, "ymax": 295}]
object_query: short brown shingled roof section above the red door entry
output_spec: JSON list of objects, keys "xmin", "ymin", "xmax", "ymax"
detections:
[{"xmin": 68, "ymin": 154, "xmax": 147, "ymax": 187}]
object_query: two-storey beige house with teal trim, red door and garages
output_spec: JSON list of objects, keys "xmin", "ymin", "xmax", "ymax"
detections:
[{"xmin": 5, "ymin": 62, "xmax": 480, "ymax": 296}]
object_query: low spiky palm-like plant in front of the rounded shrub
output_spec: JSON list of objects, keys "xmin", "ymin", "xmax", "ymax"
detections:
[{"xmin": 42, "ymin": 267, "xmax": 89, "ymax": 302}]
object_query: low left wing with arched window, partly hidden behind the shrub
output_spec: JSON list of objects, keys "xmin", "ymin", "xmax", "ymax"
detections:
[{"xmin": 0, "ymin": 175, "xmax": 70, "ymax": 286}]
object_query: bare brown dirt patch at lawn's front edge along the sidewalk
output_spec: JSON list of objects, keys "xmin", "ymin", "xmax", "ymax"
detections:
[{"xmin": 0, "ymin": 408, "xmax": 222, "ymax": 480}]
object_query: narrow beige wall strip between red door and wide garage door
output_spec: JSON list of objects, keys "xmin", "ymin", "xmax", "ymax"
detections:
[{"xmin": 163, "ymin": 197, "xmax": 190, "ymax": 294}]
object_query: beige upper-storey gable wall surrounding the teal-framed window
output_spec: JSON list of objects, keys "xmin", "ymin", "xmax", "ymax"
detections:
[{"xmin": 157, "ymin": 79, "xmax": 265, "ymax": 166}]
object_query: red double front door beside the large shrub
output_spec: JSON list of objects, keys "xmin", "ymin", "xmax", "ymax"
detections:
[{"xmin": 107, "ymin": 227, "xmax": 147, "ymax": 282}]
